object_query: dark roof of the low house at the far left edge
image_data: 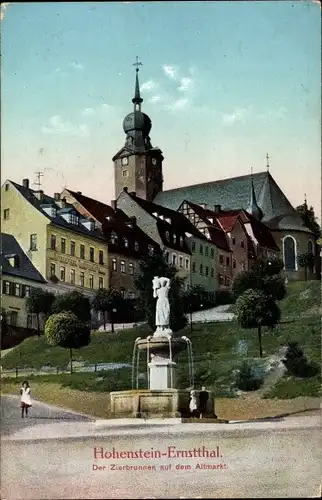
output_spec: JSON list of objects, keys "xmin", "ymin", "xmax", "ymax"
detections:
[{"xmin": 0, "ymin": 233, "xmax": 46, "ymax": 283}]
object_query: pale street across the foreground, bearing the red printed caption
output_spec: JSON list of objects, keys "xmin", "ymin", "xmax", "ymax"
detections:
[{"xmin": 1, "ymin": 397, "xmax": 321, "ymax": 500}]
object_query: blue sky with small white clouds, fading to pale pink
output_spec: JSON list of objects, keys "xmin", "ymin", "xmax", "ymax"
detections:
[{"xmin": 1, "ymin": 0, "xmax": 321, "ymax": 216}]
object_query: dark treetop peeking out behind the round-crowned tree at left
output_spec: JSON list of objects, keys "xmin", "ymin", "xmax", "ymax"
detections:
[{"xmin": 52, "ymin": 290, "xmax": 91, "ymax": 323}]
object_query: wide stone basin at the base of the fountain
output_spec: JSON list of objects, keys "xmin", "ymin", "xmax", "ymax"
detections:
[{"xmin": 110, "ymin": 389, "xmax": 190, "ymax": 418}]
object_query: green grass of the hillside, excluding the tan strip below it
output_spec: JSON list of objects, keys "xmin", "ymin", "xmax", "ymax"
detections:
[{"xmin": 2, "ymin": 281, "xmax": 321, "ymax": 398}]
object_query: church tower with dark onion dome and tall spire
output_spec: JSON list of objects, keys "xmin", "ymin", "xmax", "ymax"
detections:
[{"xmin": 113, "ymin": 58, "xmax": 163, "ymax": 201}]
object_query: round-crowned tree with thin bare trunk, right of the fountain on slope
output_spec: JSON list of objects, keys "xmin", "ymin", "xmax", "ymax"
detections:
[{"xmin": 236, "ymin": 290, "xmax": 281, "ymax": 358}]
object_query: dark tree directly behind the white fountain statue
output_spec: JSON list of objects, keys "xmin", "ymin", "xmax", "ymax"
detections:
[{"xmin": 135, "ymin": 254, "xmax": 187, "ymax": 332}]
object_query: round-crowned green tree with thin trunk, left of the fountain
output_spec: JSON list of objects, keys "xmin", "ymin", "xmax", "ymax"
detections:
[{"xmin": 45, "ymin": 311, "xmax": 90, "ymax": 373}]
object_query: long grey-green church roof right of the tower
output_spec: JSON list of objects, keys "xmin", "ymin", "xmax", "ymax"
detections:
[{"xmin": 154, "ymin": 171, "xmax": 306, "ymax": 231}]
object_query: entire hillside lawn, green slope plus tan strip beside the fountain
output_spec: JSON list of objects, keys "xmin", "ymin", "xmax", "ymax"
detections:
[{"xmin": 1, "ymin": 281, "xmax": 321, "ymax": 419}]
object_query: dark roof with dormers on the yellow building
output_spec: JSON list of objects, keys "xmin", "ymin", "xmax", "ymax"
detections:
[{"xmin": 9, "ymin": 181, "xmax": 103, "ymax": 240}]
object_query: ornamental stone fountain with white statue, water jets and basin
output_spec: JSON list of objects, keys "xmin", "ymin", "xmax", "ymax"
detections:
[{"xmin": 110, "ymin": 276, "xmax": 194, "ymax": 418}]
